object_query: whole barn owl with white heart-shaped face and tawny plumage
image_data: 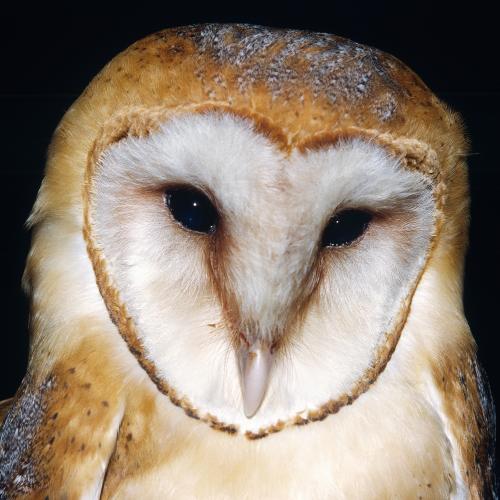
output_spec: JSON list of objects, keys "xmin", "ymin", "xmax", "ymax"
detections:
[{"xmin": 0, "ymin": 24, "xmax": 495, "ymax": 499}]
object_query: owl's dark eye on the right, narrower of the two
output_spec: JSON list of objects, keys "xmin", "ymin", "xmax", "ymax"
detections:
[{"xmin": 321, "ymin": 210, "xmax": 372, "ymax": 247}]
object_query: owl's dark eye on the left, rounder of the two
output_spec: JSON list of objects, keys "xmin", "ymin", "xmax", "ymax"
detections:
[{"xmin": 165, "ymin": 187, "xmax": 218, "ymax": 233}]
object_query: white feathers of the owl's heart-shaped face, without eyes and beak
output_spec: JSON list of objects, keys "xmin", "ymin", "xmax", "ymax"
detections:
[{"xmin": 93, "ymin": 114, "xmax": 434, "ymax": 431}]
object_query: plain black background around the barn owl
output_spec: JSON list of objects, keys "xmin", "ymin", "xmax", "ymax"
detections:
[{"xmin": 0, "ymin": 1, "xmax": 500, "ymax": 458}]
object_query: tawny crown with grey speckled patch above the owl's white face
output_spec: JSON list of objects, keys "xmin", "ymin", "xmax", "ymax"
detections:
[{"xmin": 101, "ymin": 24, "xmax": 448, "ymax": 139}]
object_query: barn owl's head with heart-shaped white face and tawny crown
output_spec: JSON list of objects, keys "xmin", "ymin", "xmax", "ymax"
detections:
[{"xmin": 25, "ymin": 25, "xmax": 467, "ymax": 438}]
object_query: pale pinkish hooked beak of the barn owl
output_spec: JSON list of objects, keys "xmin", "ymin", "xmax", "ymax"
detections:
[{"xmin": 238, "ymin": 340, "xmax": 273, "ymax": 418}]
